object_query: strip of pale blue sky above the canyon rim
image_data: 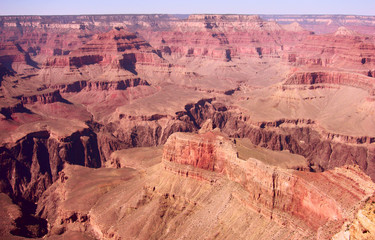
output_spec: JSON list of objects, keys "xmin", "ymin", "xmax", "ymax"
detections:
[{"xmin": 0, "ymin": 0, "xmax": 375, "ymax": 15}]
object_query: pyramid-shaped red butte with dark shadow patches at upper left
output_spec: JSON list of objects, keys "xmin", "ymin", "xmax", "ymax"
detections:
[{"xmin": 40, "ymin": 28, "xmax": 168, "ymax": 82}]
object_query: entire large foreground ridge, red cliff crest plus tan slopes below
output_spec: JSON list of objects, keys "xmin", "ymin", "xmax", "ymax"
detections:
[{"xmin": 28, "ymin": 132, "xmax": 375, "ymax": 239}]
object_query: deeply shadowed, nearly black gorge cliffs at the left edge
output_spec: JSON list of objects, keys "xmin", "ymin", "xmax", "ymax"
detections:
[{"xmin": 0, "ymin": 129, "xmax": 101, "ymax": 202}]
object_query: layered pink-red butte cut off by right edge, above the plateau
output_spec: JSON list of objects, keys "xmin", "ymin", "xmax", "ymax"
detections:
[{"xmin": 283, "ymin": 30, "xmax": 375, "ymax": 94}]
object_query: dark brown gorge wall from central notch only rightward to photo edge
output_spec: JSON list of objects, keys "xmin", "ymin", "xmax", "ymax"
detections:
[{"xmin": 181, "ymin": 99, "xmax": 375, "ymax": 179}]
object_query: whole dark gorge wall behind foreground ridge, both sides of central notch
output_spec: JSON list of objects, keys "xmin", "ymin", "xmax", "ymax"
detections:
[{"xmin": 81, "ymin": 96, "xmax": 375, "ymax": 178}]
